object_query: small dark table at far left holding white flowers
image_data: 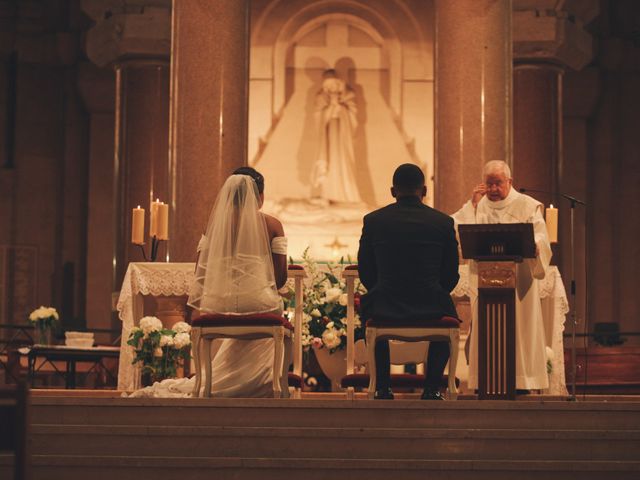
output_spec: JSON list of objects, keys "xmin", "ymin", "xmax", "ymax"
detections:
[{"xmin": 18, "ymin": 345, "xmax": 120, "ymax": 389}]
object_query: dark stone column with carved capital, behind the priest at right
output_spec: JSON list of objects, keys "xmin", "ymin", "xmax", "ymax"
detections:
[{"xmin": 513, "ymin": 0, "xmax": 593, "ymax": 204}]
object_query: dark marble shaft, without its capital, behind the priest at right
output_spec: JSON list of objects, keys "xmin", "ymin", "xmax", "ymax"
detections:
[{"xmin": 512, "ymin": 63, "xmax": 563, "ymax": 205}]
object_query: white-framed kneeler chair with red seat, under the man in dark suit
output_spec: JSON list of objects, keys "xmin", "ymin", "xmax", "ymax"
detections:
[{"xmin": 341, "ymin": 265, "xmax": 460, "ymax": 400}]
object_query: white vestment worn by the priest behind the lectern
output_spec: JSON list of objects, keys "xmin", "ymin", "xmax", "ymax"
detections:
[{"xmin": 452, "ymin": 187, "xmax": 551, "ymax": 390}]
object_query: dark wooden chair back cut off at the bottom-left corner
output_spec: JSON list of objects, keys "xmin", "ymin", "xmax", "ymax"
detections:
[{"xmin": 0, "ymin": 382, "xmax": 30, "ymax": 480}]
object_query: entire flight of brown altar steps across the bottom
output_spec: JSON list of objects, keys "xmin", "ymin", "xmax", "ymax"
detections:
[{"xmin": 0, "ymin": 397, "xmax": 640, "ymax": 480}]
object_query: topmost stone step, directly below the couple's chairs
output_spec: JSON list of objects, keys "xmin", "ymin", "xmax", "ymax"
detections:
[{"xmin": 31, "ymin": 397, "xmax": 640, "ymax": 431}]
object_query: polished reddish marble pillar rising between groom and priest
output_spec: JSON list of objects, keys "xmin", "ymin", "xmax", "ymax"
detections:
[{"xmin": 435, "ymin": 0, "xmax": 512, "ymax": 213}]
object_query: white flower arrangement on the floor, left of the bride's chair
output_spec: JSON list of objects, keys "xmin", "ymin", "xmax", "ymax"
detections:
[{"xmin": 127, "ymin": 317, "xmax": 191, "ymax": 380}]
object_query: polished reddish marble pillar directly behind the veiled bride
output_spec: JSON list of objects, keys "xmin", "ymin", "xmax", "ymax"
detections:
[{"xmin": 169, "ymin": 0, "xmax": 250, "ymax": 262}]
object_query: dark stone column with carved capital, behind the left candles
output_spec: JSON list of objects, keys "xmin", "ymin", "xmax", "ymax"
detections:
[{"xmin": 82, "ymin": 0, "xmax": 171, "ymax": 284}]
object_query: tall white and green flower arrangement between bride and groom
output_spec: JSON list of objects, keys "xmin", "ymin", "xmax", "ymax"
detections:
[{"xmin": 286, "ymin": 248, "xmax": 365, "ymax": 353}]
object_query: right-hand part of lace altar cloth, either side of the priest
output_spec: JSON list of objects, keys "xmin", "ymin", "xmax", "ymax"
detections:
[{"xmin": 451, "ymin": 264, "xmax": 569, "ymax": 395}]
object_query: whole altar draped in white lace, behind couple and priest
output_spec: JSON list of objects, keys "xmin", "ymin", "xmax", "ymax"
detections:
[{"xmin": 117, "ymin": 262, "xmax": 569, "ymax": 395}]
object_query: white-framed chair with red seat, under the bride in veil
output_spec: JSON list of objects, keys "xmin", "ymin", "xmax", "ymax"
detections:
[{"xmin": 191, "ymin": 265, "xmax": 305, "ymax": 398}]
